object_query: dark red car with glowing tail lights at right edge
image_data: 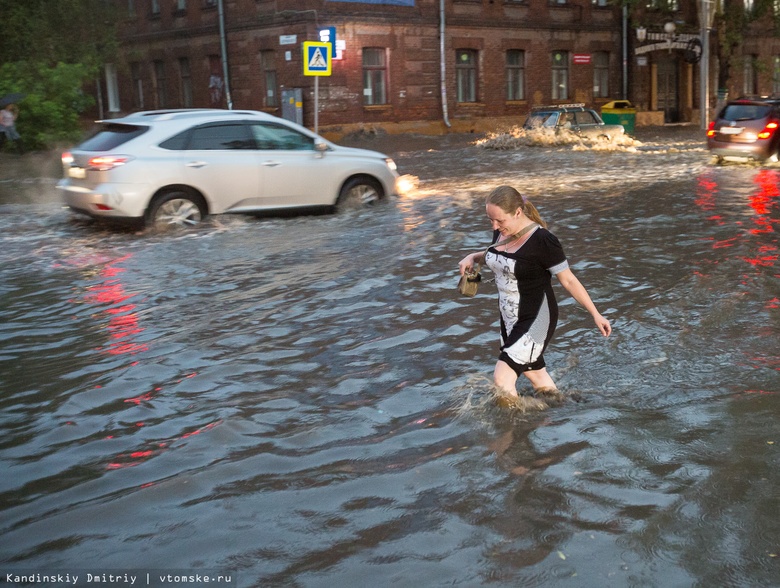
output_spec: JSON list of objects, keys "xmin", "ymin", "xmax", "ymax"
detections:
[{"xmin": 707, "ymin": 97, "xmax": 780, "ymax": 163}]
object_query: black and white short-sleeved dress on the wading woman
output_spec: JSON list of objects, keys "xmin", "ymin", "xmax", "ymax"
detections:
[{"xmin": 485, "ymin": 227, "xmax": 569, "ymax": 374}]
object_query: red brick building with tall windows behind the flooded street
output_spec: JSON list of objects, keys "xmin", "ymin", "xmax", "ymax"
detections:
[{"xmin": 106, "ymin": 0, "xmax": 771, "ymax": 132}]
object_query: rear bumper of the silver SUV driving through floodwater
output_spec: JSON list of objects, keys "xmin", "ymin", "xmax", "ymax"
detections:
[{"xmin": 57, "ymin": 180, "xmax": 148, "ymax": 219}]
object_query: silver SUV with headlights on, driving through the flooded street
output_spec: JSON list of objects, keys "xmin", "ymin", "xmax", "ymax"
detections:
[{"xmin": 57, "ymin": 109, "xmax": 399, "ymax": 228}]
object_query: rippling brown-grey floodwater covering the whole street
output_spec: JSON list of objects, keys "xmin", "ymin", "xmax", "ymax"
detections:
[{"xmin": 0, "ymin": 126, "xmax": 780, "ymax": 588}]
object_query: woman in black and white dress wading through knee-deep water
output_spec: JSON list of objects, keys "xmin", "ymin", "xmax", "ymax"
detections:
[{"xmin": 458, "ymin": 186, "xmax": 612, "ymax": 408}]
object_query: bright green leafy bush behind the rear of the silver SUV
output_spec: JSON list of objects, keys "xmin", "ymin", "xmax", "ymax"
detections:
[{"xmin": 0, "ymin": 62, "xmax": 94, "ymax": 149}]
